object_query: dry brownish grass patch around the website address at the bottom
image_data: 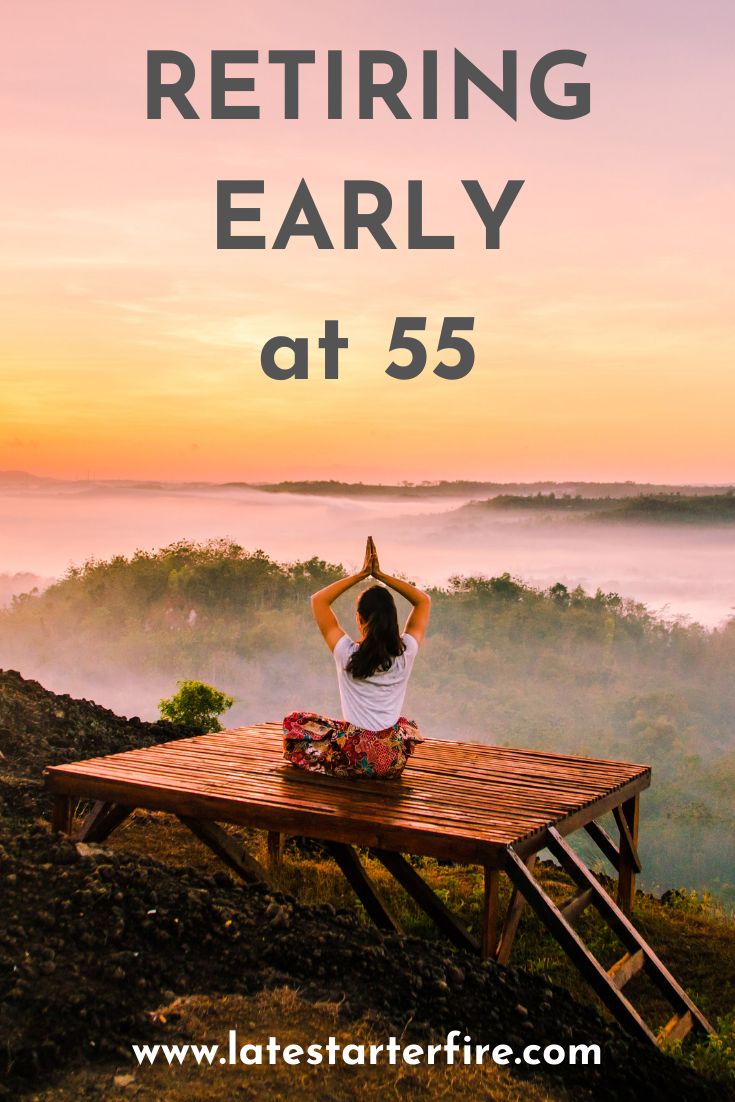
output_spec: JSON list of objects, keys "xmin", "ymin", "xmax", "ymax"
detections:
[{"xmin": 34, "ymin": 987, "xmax": 570, "ymax": 1102}]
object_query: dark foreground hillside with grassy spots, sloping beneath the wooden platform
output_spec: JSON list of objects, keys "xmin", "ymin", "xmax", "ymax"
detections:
[{"xmin": 0, "ymin": 671, "xmax": 733, "ymax": 1102}]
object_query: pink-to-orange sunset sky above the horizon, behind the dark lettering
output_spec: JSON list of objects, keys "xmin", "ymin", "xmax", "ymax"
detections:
[{"xmin": 0, "ymin": 0, "xmax": 735, "ymax": 483}]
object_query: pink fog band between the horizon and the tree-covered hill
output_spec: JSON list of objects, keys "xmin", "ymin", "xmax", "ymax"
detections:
[{"xmin": 0, "ymin": 483, "xmax": 735, "ymax": 627}]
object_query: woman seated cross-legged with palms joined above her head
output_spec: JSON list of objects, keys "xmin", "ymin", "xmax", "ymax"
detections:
[{"xmin": 283, "ymin": 537, "xmax": 431, "ymax": 778}]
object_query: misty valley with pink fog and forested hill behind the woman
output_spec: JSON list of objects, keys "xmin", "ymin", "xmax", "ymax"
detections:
[{"xmin": 0, "ymin": 484, "xmax": 735, "ymax": 906}]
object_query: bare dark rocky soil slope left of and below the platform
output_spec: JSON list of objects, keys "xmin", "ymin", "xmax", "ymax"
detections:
[{"xmin": 0, "ymin": 671, "xmax": 725, "ymax": 1100}]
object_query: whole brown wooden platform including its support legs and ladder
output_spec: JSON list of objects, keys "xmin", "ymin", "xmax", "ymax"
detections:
[{"xmin": 46, "ymin": 724, "xmax": 710, "ymax": 1039}]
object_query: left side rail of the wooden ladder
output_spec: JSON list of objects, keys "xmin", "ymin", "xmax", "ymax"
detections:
[{"xmin": 506, "ymin": 846, "xmax": 656, "ymax": 1044}]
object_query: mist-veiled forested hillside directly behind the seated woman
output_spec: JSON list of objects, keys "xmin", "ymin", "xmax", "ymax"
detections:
[{"xmin": 0, "ymin": 541, "xmax": 735, "ymax": 906}]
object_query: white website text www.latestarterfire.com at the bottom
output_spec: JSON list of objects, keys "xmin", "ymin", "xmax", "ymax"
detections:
[{"xmin": 132, "ymin": 1029, "xmax": 601, "ymax": 1067}]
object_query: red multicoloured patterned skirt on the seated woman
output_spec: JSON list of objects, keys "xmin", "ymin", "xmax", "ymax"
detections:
[{"xmin": 283, "ymin": 712, "xmax": 423, "ymax": 780}]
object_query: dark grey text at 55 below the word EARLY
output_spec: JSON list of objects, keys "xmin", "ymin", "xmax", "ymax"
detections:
[{"xmin": 260, "ymin": 317, "xmax": 475, "ymax": 381}]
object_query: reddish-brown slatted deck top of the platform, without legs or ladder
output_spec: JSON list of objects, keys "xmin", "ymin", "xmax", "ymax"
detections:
[{"xmin": 47, "ymin": 724, "xmax": 650, "ymax": 867}]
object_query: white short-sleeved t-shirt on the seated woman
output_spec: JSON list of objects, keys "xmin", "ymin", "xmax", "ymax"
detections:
[{"xmin": 333, "ymin": 635, "xmax": 419, "ymax": 731}]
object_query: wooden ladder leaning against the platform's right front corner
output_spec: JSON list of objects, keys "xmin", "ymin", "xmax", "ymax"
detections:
[{"xmin": 506, "ymin": 827, "xmax": 713, "ymax": 1044}]
